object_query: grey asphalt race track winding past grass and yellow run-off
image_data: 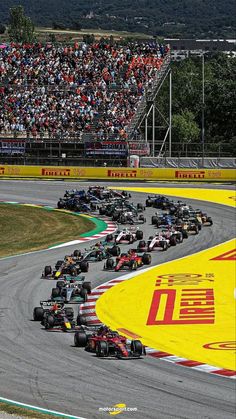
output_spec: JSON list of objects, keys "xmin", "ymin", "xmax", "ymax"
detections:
[{"xmin": 0, "ymin": 180, "xmax": 235, "ymax": 419}]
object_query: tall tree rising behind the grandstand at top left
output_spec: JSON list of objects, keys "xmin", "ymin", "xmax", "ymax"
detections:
[{"xmin": 8, "ymin": 6, "xmax": 35, "ymax": 42}]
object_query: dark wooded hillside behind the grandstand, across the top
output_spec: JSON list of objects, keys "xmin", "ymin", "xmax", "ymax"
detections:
[{"xmin": 0, "ymin": 0, "xmax": 236, "ymax": 38}]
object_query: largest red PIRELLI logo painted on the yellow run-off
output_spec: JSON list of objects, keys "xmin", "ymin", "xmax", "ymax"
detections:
[{"xmin": 147, "ymin": 288, "xmax": 215, "ymax": 326}]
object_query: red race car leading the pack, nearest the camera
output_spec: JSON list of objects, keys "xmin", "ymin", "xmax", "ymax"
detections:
[{"xmin": 74, "ymin": 326, "xmax": 146, "ymax": 359}]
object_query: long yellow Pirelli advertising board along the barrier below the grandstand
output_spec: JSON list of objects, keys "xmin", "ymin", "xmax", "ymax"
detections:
[{"xmin": 0, "ymin": 165, "xmax": 236, "ymax": 182}]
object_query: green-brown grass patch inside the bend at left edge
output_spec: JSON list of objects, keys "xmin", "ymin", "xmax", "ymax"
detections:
[{"xmin": 0, "ymin": 204, "xmax": 95, "ymax": 257}]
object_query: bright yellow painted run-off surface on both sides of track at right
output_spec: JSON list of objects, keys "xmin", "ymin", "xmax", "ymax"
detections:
[{"xmin": 96, "ymin": 188, "xmax": 236, "ymax": 370}]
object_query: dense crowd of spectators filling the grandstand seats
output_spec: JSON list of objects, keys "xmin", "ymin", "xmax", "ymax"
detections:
[{"xmin": 0, "ymin": 40, "xmax": 168, "ymax": 139}]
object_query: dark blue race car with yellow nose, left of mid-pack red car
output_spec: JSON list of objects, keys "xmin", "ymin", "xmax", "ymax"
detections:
[{"xmin": 42, "ymin": 256, "xmax": 89, "ymax": 279}]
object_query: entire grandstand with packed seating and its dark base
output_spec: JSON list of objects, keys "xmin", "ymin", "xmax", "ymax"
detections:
[{"xmin": 0, "ymin": 39, "xmax": 170, "ymax": 164}]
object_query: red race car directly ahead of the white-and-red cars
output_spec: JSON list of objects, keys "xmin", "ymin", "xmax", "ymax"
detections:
[{"xmin": 104, "ymin": 249, "xmax": 152, "ymax": 272}]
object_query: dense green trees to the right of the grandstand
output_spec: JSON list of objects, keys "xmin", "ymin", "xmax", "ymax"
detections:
[{"xmin": 157, "ymin": 54, "xmax": 236, "ymax": 154}]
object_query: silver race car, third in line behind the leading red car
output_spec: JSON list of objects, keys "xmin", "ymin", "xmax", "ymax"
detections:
[{"xmin": 51, "ymin": 279, "xmax": 91, "ymax": 304}]
